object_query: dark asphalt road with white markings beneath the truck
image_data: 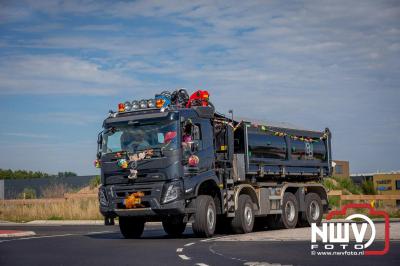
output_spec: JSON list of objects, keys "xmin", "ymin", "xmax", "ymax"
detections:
[{"xmin": 0, "ymin": 224, "xmax": 400, "ymax": 266}]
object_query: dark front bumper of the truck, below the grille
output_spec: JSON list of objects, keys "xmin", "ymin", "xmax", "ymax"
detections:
[{"xmin": 100, "ymin": 182, "xmax": 188, "ymax": 220}]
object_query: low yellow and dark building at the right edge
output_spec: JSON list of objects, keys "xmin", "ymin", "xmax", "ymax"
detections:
[{"xmin": 351, "ymin": 171, "xmax": 400, "ymax": 208}]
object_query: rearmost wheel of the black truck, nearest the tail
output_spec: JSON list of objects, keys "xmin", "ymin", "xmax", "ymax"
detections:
[{"xmin": 301, "ymin": 193, "xmax": 323, "ymax": 226}]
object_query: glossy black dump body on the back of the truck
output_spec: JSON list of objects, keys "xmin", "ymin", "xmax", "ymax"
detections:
[{"xmin": 234, "ymin": 122, "xmax": 332, "ymax": 181}]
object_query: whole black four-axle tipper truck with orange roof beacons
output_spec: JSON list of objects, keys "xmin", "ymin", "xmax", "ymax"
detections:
[{"xmin": 95, "ymin": 90, "xmax": 332, "ymax": 238}]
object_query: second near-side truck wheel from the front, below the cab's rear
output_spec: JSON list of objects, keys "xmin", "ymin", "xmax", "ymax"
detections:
[{"xmin": 231, "ymin": 194, "xmax": 254, "ymax": 234}]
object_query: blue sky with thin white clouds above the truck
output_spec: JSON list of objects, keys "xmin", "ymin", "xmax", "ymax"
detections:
[{"xmin": 0, "ymin": 0, "xmax": 400, "ymax": 174}]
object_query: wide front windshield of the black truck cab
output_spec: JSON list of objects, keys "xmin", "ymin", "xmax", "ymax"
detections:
[{"xmin": 102, "ymin": 119, "xmax": 178, "ymax": 154}]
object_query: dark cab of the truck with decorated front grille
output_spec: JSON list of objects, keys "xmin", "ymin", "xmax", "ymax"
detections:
[{"xmin": 98, "ymin": 104, "xmax": 220, "ymax": 237}]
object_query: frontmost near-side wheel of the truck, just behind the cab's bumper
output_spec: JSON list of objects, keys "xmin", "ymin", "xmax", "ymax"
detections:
[{"xmin": 192, "ymin": 195, "xmax": 217, "ymax": 237}]
